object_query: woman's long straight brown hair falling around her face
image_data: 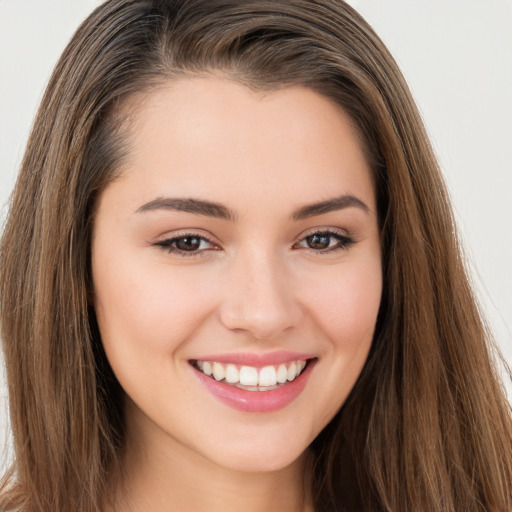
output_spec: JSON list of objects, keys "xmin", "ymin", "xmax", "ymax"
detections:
[{"xmin": 0, "ymin": 0, "xmax": 512, "ymax": 512}]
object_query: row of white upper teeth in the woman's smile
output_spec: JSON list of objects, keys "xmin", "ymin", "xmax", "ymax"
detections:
[{"xmin": 196, "ymin": 361, "xmax": 306, "ymax": 386}]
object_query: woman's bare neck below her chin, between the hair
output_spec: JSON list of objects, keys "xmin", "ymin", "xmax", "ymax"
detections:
[{"xmin": 106, "ymin": 404, "xmax": 313, "ymax": 512}]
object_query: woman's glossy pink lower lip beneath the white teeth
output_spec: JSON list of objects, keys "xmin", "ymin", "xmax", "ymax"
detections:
[{"xmin": 191, "ymin": 359, "xmax": 316, "ymax": 412}]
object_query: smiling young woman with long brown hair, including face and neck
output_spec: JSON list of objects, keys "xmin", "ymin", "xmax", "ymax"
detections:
[{"xmin": 0, "ymin": 0, "xmax": 512, "ymax": 512}]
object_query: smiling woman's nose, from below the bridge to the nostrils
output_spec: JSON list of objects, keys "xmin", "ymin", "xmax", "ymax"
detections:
[{"xmin": 220, "ymin": 251, "xmax": 302, "ymax": 340}]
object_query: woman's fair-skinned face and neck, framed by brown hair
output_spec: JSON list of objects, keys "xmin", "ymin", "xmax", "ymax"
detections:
[{"xmin": 92, "ymin": 77, "xmax": 382, "ymax": 512}]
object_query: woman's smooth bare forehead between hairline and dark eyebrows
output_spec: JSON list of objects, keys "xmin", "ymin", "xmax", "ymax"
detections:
[{"xmin": 107, "ymin": 77, "xmax": 374, "ymax": 217}]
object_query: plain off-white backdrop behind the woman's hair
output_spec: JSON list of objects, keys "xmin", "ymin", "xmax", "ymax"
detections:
[{"xmin": 0, "ymin": 0, "xmax": 512, "ymax": 469}]
